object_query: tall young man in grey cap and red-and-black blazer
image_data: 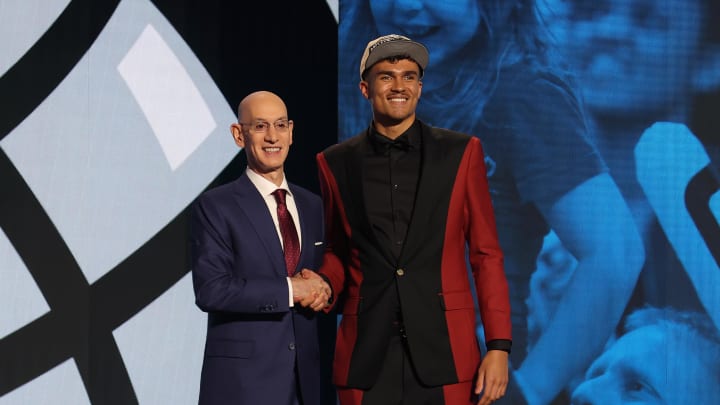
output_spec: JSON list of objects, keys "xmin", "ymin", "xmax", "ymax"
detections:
[{"xmin": 317, "ymin": 35, "xmax": 511, "ymax": 405}]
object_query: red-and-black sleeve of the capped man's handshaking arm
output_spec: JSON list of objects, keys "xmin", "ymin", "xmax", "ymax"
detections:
[{"xmin": 317, "ymin": 153, "xmax": 349, "ymax": 311}]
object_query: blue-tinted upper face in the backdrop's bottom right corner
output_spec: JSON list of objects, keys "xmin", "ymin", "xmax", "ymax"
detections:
[{"xmin": 572, "ymin": 324, "xmax": 719, "ymax": 405}]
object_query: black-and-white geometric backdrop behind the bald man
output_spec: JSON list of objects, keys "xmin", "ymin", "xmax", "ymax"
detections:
[{"xmin": 0, "ymin": 0, "xmax": 337, "ymax": 405}]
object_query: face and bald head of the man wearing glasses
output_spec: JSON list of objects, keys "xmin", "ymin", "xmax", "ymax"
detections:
[{"xmin": 230, "ymin": 92, "xmax": 293, "ymax": 185}]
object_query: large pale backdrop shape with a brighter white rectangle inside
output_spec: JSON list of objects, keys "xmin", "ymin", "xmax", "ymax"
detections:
[{"xmin": 0, "ymin": 0, "xmax": 239, "ymax": 284}]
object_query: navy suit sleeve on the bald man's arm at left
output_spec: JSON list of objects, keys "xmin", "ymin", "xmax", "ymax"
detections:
[{"xmin": 190, "ymin": 197, "xmax": 290, "ymax": 314}]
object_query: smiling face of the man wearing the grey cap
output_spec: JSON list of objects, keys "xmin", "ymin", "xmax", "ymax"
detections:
[{"xmin": 360, "ymin": 59, "xmax": 422, "ymax": 138}]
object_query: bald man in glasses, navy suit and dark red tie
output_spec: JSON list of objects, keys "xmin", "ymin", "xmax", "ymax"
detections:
[{"xmin": 191, "ymin": 91, "xmax": 330, "ymax": 405}]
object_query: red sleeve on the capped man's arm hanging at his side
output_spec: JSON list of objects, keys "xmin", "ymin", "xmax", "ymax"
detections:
[{"xmin": 465, "ymin": 138, "xmax": 511, "ymax": 342}]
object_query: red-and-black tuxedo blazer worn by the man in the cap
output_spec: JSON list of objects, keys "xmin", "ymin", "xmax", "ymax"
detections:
[{"xmin": 317, "ymin": 124, "xmax": 511, "ymax": 389}]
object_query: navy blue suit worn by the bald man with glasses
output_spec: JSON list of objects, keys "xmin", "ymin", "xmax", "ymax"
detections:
[{"xmin": 191, "ymin": 174, "xmax": 324, "ymax": 405}]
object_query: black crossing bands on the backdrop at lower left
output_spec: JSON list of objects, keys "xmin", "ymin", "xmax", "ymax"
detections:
[{"xmin": 0, "ymin": 144, "xmax": 243, "ymax": 404}]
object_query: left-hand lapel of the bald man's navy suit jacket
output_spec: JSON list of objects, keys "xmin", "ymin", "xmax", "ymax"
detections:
[{"xmin": 235, "ymin": 174, "xmax": 287, "ymax": 275}]
